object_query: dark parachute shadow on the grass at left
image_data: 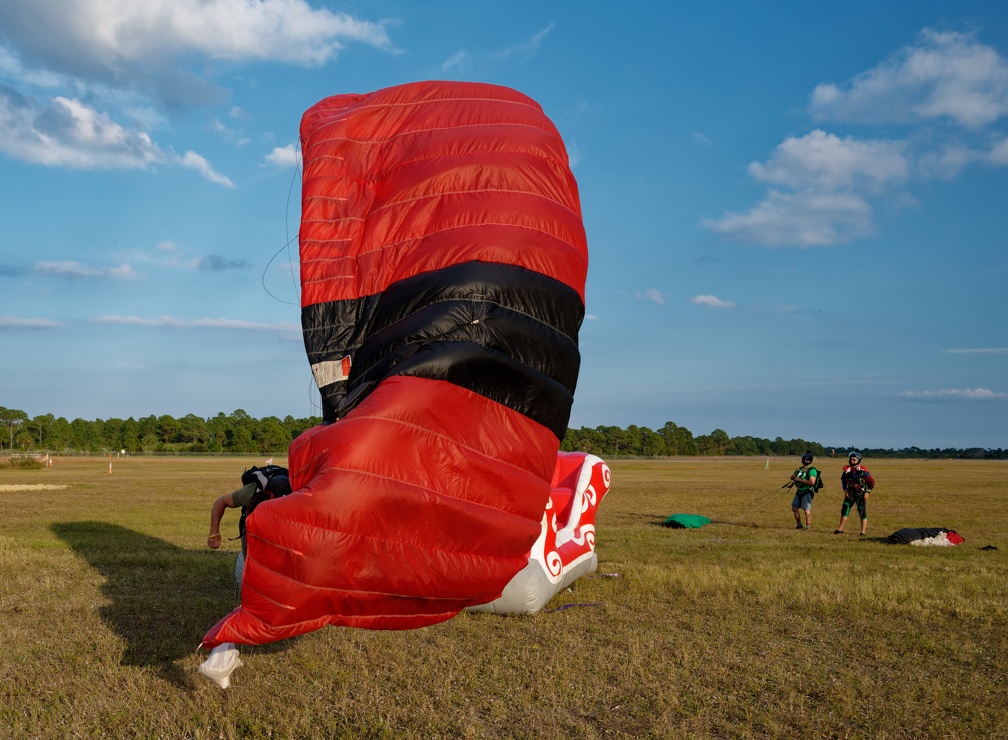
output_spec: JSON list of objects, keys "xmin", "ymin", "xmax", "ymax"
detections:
[{"xmin": 51, "ymin": 521, "xmax": 258, "ymax": 687}]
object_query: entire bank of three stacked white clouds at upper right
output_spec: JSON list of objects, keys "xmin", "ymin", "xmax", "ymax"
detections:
[{"xmin": 702, "ymin": 30, "xmax": 1008, "ymax": 247}]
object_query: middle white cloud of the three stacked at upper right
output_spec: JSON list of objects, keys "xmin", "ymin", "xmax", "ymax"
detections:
[{"xmin": 749, "ymin": 129, "xmax": 909, "ymax": 192}]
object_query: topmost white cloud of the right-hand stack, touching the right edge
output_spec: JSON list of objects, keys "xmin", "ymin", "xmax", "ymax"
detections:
[{"xmin": 810, "ymin": 29, "xmax": 1008, "ymax": 127}]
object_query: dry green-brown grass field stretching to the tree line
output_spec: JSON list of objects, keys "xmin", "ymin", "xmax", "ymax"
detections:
[{"xmin": 0, "ymin": 458, "xmax": 1008, "ymax": 738}]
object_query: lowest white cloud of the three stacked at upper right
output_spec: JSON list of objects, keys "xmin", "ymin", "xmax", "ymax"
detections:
[{"xmin": 703, "ymin": 191, "xmax": 874, "ymax": 247}]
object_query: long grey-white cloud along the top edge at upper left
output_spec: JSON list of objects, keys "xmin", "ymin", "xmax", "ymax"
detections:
[{"xmin": 0, "ymin": 0, "xmax": 391, "ymax": 79}]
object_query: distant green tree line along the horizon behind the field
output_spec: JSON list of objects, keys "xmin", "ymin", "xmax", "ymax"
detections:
[{"xmin": 0, "ymin": 406, "xmax": 1008, "ymax": 460}]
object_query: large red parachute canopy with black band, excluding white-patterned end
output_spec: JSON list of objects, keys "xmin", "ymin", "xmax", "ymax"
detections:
[{"xmin": 204, "ymin": 82, "xmax": 588, "ymax": 647}]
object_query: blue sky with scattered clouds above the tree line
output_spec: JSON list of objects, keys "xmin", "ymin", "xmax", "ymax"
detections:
[{"xmin": 0, "ymin": 0, "xmax": 1008, "ymax": 448}]
